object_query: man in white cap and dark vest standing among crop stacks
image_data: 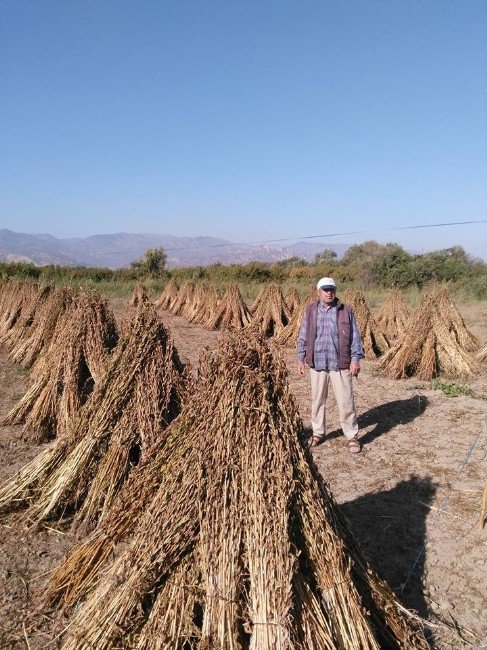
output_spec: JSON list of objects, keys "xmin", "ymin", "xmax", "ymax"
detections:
[{"xmin": 297, "ymin": 278, "xmax": 364, "ymax": 454}]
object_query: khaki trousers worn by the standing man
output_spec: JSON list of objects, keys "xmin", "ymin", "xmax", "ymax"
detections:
[{"xmin": 309, "ymin": 368, "xmax": 358, "ymax": 440}]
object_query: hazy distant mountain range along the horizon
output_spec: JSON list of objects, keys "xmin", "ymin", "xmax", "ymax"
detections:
[{"xmin": 0, "ymin": 229, "xmax": 348, "ymax": 269}]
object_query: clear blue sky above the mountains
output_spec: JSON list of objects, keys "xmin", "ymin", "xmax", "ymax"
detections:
[{"xmin": 0, "ymin": 0, "xmax": 487, "ymax": 258}]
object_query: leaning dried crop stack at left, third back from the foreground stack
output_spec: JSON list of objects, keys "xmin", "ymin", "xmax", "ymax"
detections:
[{"xmin": 4, "ymin": 294, "xmax": 118, "ymax": 441}]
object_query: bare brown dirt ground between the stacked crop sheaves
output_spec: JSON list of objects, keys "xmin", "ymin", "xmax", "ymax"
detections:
[{"xmin": 0, "ymin": 301, "xmax": 487, "ymax": 650}]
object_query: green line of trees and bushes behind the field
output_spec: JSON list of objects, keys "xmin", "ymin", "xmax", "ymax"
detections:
[{"xmin": 0, "ymin": 240, "xmax": 487, "ymax": 299}]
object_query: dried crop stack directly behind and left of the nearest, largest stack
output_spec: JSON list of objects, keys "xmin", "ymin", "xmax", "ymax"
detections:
[{"xmin": 0, "ymin": 306, "xmax": 186, "ymax": 526}]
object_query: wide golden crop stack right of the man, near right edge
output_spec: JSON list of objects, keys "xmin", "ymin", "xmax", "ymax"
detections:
[{"xmin": 379, "ymin": 292, "xmax": 478, "ymax": 381}]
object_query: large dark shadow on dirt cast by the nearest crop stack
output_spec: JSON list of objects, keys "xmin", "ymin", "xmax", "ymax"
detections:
[{"xmin": 341, "ymin": 476, "xmax": 436, "ymax": 647}]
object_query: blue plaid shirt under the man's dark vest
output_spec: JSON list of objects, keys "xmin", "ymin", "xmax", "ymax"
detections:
[{"xmin": 297, "ymin": 301, "xmax": 364, "ymax": 370}]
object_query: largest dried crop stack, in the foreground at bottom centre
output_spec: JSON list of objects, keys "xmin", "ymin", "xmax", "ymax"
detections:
[{"xmin": 45, "ymin": 334, "xmax": 428, "ymax": 650}]
